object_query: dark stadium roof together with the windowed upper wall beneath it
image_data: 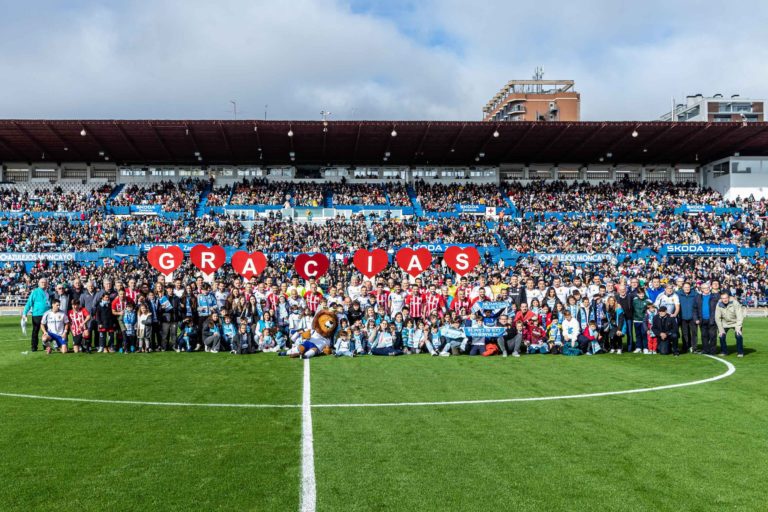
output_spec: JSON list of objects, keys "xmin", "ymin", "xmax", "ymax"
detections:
[{"xmin": 0, "ymin": 120, "xmax": 768, "ymax": 199}]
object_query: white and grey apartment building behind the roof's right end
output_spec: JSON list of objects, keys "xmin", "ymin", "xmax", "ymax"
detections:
[{"xmin": 661, "ymin": 94, "xmax": 765, "ymax": 123}]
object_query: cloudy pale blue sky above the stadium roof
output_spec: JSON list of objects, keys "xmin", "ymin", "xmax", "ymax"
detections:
[{"xmin": 0, "ymin": 0, "xmax": 768, "ymax": 120}]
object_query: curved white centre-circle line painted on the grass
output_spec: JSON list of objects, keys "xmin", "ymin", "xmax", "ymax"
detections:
[{"xmin": 0, "ymin": 355, "xmax": 736, "ymax": 412}]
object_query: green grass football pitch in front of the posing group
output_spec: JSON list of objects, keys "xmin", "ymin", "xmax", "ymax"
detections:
[{"xmin": 0, "ymin": 318, "xmax": 768, "ymax": 512}]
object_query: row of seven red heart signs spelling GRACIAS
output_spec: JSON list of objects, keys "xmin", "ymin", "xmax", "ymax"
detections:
[{"xmin": 147, "ymin": 244, "xmax": 480, "ymax": 279}]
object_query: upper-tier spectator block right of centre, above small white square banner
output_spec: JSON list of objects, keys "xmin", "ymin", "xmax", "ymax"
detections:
[{"xmin": 415, "ymin": 180, "xmax": 507, "ymax": 212}]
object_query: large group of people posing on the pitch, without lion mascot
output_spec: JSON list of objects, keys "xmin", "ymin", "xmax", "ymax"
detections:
[{"xmin": 23, "ymin": 262, "xmax": 744, "ymax": 357}]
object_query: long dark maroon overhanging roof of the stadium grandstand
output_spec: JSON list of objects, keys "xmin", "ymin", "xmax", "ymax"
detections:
[{"xmin": 0, "ymin": 120, "xmax": 768, "ymax": 166}]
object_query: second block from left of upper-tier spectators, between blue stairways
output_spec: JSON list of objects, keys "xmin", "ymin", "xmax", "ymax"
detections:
[{"xmin": 112, "ymin": 178, "xmax": 208, "ymax": 214}]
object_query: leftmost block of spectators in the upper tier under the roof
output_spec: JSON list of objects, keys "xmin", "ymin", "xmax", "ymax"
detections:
[{"xmin": 0, "ymin": 184, "xmax": 112, "ymax": 212}]
